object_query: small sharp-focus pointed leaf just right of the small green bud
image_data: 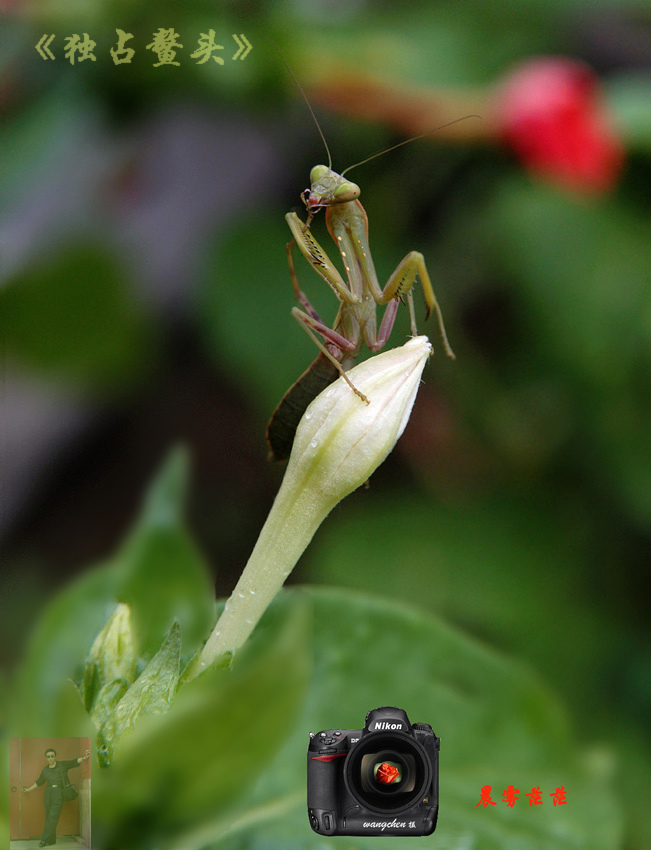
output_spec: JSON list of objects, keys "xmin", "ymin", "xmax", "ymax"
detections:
[{"xmin": 98, "ymin": 623, "xmax": 181, "ymax": 764}]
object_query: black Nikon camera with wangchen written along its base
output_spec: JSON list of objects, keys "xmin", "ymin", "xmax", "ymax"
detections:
[{"xmin": 307, "ymin": 706, "xmax": 440, "ymax": 835}]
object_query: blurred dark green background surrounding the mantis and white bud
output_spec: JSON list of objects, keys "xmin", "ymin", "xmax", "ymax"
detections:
[{"xmin": 0, "ymin": 0, "xmax": 651, "ymax": 848}]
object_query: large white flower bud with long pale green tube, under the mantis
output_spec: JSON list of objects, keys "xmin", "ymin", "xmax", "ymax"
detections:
[{"xmin": 197, "ymin": 336, "xmax": 432, "ymax": 672}]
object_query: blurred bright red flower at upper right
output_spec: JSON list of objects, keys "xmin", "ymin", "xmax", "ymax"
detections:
[{"xmin": 496, "ymin": 57, "xmax": 624, "ymax": 193}]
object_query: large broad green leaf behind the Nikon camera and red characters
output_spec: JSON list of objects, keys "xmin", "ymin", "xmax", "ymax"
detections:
[{"xmin": 211, "ymin": 589, "xmax": 620, "ymax": 850}]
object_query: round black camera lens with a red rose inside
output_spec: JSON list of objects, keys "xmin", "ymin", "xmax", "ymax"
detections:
[{"xmin": 344, "ymin": 733, "xmax": 431, "ymax": 813}]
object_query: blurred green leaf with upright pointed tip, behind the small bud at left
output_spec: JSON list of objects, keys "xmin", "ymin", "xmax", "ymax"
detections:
[{"xmin": 11, "ymin": 451, "xmax": 215, "ymax": 735}]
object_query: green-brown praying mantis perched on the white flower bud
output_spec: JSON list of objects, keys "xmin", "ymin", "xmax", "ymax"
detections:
[{"xmin": 267, "ymin": 69, "xmax": 469, "ymax": 460}]
